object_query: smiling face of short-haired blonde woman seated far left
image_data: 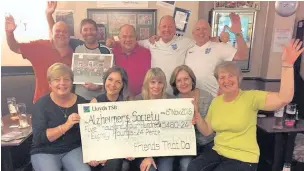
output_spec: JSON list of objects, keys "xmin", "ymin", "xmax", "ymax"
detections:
[{"xmin": 49, "ymin": 74, "xmax": 72, "ymax": 97}]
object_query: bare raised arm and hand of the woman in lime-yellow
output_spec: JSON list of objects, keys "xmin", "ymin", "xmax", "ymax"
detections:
[{"xmin": 264, "ymin": 39, "xmax": 304, "ymax": 111}]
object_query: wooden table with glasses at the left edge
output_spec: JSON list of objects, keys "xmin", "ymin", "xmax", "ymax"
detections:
[{"xmin": 1, "ymin": 114, "xmax": 32, "ymax": 171}]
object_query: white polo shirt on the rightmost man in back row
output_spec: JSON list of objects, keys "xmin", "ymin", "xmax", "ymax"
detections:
[{"xmin": 185, "ymin": 41, "xmax": 237, "ymax": 97}]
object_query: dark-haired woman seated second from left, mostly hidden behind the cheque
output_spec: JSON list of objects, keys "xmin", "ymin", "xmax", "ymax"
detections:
[{"xmin": 89, "ymin": 66, "xmax": 128, "ymax": 171}]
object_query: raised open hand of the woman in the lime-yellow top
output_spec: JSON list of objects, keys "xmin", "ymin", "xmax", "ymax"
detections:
[{"xmin": 282, "ymin": 39, "xmax": 304, "ymax": 65}]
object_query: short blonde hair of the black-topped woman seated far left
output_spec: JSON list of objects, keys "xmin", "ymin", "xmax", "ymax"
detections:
[{"xmin": 47, "ymin": 63, "xmax": 74, "ymax": 82}]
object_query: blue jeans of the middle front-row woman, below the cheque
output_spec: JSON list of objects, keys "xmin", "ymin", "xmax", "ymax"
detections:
[{"xmin": 138, "ymin": 156, "xmax": 174, "ymax": 171}]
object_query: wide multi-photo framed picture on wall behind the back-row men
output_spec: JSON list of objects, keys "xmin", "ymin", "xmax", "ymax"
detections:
[{"xmin": 87, "ymin": 9, "xmax": 157, "ymax": 42}]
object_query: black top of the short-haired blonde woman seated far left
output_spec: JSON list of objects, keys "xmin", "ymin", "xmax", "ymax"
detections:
[{"xmin": 31, "ymin": 94, "xmax": 87, "ymax": 154}]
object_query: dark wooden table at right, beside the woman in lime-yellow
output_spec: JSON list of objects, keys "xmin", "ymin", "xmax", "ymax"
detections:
[{"xmin": 257, "ymin": 117, "xmax": 304, "ymax": 171}]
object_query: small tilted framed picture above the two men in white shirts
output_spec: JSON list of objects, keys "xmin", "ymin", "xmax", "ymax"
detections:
[{"xmin": 173, "ymin": 8, "xmax": 191, "ymax": 34}]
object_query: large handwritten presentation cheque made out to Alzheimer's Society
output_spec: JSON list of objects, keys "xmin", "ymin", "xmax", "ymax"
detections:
[{"xmin": 78, "ymin": 98, "xmax": 196, "ymax": 163}]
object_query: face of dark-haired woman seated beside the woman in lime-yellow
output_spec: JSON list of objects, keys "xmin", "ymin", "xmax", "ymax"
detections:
[{"xmin": 175, "ymin": 70, "xmax": 193, "ymax": 94}]
